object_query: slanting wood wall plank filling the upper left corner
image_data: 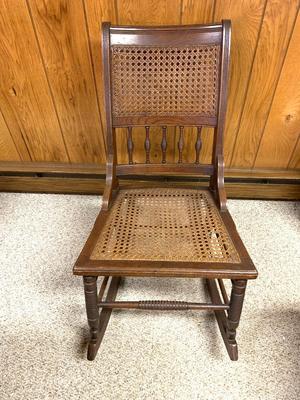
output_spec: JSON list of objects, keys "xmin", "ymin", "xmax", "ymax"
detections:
[{"xmin": 0, "ymin": 0, "xmax": 68, "ymax": 161}]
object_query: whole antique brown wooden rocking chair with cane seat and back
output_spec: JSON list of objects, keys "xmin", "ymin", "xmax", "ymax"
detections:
[{"xmin": 74, "ymin": 21, "xmax": 257, "ymax": 360}]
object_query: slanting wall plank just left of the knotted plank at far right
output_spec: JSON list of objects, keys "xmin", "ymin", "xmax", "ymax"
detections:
[{"xmin": 231, "ymin": 0, "xmax": 299, "ymax": 168}]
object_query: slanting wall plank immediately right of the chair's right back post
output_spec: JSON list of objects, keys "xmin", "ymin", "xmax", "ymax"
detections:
[{"xmin": 214, "ymin": 0, "xmax": 266, "ymax": 165}]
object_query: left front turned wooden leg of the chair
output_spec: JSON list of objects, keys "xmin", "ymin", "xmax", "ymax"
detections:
[{"xmin": 83, "ymin": 276, "xmax": 99, "ymax": 342}]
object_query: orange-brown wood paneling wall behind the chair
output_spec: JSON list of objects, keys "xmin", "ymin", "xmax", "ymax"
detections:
[{"xmin": 0, "ymin": 0, "xmax": 300, "ymax": 169}]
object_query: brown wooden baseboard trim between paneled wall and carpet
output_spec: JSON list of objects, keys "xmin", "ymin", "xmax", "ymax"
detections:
[{"xmin": 0, "ymin": 162, "xmax": 300, "ymax": 200}]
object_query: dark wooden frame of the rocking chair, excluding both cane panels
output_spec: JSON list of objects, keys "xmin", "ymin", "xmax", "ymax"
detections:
[{"xmin": 74, "ymin": 20, "xmax": 257, "ymax": 360}]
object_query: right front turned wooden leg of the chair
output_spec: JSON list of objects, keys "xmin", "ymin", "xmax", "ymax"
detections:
[{"xmin": 227, "ymin": 280, "xmax": 247, "ymax": 342}]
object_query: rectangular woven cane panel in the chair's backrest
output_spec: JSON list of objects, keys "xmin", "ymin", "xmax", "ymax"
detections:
[{"xmin": 112, "ymin": 45, "xmax": 220, "ymax": 117}]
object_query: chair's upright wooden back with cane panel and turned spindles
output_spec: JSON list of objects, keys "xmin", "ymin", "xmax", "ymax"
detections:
[{"xmin": 102, "ymin": 21, "xmax": 230, "ymax": 175}]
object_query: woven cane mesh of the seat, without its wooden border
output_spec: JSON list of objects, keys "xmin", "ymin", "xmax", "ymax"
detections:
[{"xmin": 91, "ymin": 188, "xmax": 240, "ymax": 263}]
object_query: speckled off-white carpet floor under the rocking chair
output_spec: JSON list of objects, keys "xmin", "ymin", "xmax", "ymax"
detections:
[{"xmin": 0, "ymin": 193, "xmax": 300, "ymax": 400}]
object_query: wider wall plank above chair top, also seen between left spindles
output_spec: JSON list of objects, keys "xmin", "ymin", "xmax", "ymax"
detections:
[{"xmin": 117, "ymin": 0, "xmax": 181, "ymax": 162}]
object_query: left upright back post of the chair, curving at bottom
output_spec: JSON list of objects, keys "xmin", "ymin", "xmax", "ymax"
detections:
[{"xmin": 102, "ymin": 22, "xmax": 118, "ymax": 210}]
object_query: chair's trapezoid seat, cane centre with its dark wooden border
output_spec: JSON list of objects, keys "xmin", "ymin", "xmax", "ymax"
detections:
[{"xmin": 74, "ymin": 187, "xmax": 256, "ymax": 278}]
